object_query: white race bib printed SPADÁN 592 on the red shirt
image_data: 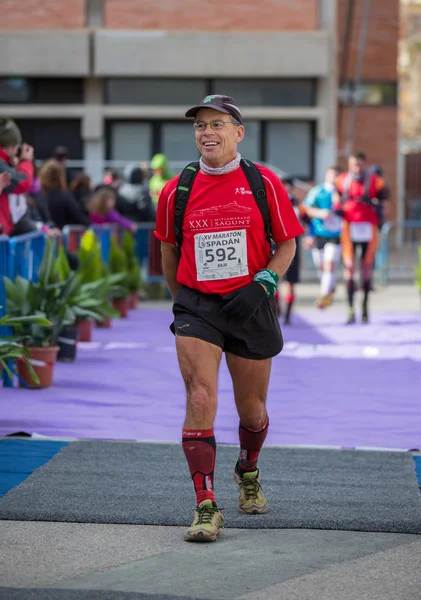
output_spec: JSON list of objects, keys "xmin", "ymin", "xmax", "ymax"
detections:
[{"xmin": 194, "ymin": 229, "xmax": 249, "ymax": 281}]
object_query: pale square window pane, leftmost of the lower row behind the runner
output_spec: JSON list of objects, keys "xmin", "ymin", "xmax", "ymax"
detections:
[{"xmin": 109, "ymin": 121, "xmax": 152, "ymax": 162}]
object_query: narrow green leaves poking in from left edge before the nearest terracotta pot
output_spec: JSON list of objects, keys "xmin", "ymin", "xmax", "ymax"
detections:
[{"xmin": 0, "ymin": 308, "xmax": 52, "ymax": 383}]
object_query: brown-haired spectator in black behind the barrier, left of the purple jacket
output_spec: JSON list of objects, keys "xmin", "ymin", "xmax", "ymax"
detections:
[{"xmin": 40, "ymin": 159, "xmax": 91, "ymax": 229}]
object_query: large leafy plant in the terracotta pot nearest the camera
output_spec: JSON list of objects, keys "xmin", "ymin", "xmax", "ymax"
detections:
[{"xmin": 4, "ymin": 239, "xmax": 75, "ymax": 387}]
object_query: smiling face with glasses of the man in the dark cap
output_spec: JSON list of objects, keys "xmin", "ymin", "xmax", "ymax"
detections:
[{"xmin": 195, "ymin": 108, "xmax": 244, "ymax": 168}]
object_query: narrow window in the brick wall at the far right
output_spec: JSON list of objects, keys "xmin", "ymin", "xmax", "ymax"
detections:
[{"xmin": 339, "ymin": 81, "xmax": 397, "ymax": 106}]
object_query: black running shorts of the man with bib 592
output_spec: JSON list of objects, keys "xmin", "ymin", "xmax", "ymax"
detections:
[{"xmin": 171, "ymin": 286, "xmax": 283, "ymax": 360}]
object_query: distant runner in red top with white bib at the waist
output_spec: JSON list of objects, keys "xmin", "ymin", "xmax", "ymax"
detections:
[{"xmin": 335, "ymin": 152, "xmax": 387, "ymax": 325}]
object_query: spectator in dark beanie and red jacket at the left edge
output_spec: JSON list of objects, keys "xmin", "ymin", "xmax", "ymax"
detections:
[{"xmin": 0, "ymin": 119, "xmax": 34, "ymax": 235}]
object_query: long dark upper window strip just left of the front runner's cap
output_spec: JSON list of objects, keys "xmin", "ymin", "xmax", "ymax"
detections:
[{"xmin": 105, "ymin": 79, "xmax": 207, "ymax": 108}]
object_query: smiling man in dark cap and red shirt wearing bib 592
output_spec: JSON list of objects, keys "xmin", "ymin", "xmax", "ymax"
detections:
[{"xmin": 155, "ymin": 95, "xmax": 303, "ymax": 542}]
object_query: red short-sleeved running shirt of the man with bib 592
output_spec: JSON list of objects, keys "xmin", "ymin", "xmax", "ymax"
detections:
[{"xmin": 154, "ymin": 165, "xmax": 304, "ymax": 296}]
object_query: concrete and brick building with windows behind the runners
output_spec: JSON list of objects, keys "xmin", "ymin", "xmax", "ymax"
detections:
[{"xmin": 0, "ymin": 0, "xmax": 398, "ymax": 214}]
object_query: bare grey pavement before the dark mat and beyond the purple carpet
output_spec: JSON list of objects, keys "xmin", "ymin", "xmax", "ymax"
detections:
[{"xmin": 0, "ymin": 284, "xmax": 421, "ymax": 600}]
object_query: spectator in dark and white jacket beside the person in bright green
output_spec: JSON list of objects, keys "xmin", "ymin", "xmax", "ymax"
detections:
[{"xmin": 116, "ymin": 163, "xmax": 155, "ymax": 222}]
